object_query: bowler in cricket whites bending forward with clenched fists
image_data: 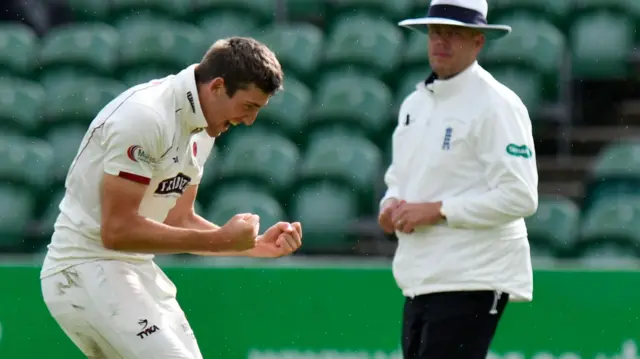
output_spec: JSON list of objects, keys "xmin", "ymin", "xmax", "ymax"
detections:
[{"xmin": 41, "ymin": 37, "xmax": 302, "ymax": 359}]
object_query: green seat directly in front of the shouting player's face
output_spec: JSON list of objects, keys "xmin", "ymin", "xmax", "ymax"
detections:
[{"xmin": 257, "ymin": 76, "xmax": 312, "ymax": 140}]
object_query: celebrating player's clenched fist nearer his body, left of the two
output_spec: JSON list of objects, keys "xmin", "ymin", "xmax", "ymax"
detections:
[{"xmin": 220, "ymin": 213, "xmax": 260, "ymax": 252}]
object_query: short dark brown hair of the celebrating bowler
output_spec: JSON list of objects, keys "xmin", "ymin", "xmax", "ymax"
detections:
[{"xmin": 195, "ymin": 37, "xmax": 284, "ymax": 97}]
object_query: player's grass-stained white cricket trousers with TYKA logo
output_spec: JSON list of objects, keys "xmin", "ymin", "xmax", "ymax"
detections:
[{"xmin": 42, "ymin": 260, "xmax": 202, "ymax": 359}]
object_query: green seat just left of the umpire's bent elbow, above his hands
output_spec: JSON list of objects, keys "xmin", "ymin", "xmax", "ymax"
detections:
[{"xmin": 299, "ymin": 133, "xmax": 383, "ymax": 211}]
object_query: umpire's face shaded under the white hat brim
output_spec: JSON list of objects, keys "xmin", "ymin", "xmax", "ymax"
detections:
[{"xmin": 428, "ymin": 25, "xmax": 485, "ymax": 78}]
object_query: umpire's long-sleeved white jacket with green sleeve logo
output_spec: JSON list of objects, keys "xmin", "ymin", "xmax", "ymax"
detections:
[{"xmin": 381, "ymin": 63, "xmax": 538, "ymax": 301}]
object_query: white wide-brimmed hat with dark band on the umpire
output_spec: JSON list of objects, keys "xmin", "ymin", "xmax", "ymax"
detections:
[{"xmin": 398, "ymin": 0, "xmax": 510, "ymax": 39}]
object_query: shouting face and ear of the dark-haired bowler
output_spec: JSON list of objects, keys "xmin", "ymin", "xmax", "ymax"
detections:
[{"xmin": 203, "ymin": 79, "xmax": 270, "ymax": 137}]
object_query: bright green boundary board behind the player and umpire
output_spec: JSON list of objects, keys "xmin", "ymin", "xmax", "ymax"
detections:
[{"xmin": 0, "ymin": 261, "xmax": 640, "ymax": 359}]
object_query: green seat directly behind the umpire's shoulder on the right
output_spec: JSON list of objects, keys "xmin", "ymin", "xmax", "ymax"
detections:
[{"xmin": 487, "ymin": 66, "xmax": 542, "ymax": 118}]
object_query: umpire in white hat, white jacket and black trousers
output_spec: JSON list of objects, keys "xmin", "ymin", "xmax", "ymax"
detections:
[{"xmin": 379, "ymin": 0, "xmax": 538, "ymax": 359}]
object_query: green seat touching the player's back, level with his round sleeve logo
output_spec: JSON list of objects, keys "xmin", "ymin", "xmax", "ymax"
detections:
[{"xmin": 45, "ymin": 125, "xmax": 87, "ymax": 184}]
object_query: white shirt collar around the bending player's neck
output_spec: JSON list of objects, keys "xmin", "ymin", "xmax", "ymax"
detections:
[{"xmin": 175, "ymin": 64, "xmax": 207, "ymax": 130}]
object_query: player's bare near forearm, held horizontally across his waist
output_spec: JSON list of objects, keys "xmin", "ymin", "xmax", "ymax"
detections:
[{"xmin": 102, "ymin": 216, "xmax": 228, "ymax": 254}]
